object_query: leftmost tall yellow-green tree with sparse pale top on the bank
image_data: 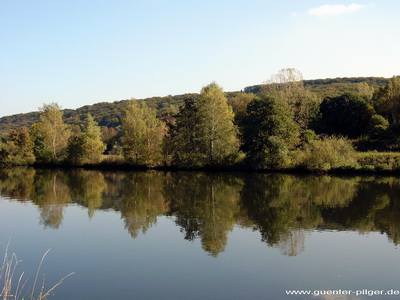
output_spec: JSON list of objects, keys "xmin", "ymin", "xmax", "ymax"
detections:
[{"xmin": 31, "ymin": 103, "xmax": 70, "ymax": 162}]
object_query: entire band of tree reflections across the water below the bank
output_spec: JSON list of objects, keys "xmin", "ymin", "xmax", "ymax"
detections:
[{"xmin": 0, "ymin": 168, "xmax": 400, "ymax": 256}]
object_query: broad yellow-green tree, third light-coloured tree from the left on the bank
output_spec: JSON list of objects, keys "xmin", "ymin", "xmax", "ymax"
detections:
[{"xmin": 122, "ymin": 100, "xmax": 166, "ymax": 165}]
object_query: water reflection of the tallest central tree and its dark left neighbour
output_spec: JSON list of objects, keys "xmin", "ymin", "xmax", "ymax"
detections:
[{"xmin": 164, "ymin": 173, "xmax": 242, "ymax": 256}]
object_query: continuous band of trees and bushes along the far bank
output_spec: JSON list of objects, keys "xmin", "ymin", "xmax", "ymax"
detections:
[{"xmin": 0, "ymin": 69, "xmax": 400, "ymax": 174}]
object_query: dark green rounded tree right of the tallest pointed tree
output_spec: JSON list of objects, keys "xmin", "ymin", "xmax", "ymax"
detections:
[{"xmin": 241, "ymin": 96, "xmax": 299, "ymax": 169}]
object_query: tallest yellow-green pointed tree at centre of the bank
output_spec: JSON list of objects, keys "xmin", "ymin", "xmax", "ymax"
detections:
[{"xmin": 198, "ymin": 82, "xmax": 239, "ymax": 166}]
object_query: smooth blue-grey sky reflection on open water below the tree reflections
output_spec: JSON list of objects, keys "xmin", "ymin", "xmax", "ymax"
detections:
[{"xmin": 0, "ymin": 200, "xmax": 400, "ymax": 300}]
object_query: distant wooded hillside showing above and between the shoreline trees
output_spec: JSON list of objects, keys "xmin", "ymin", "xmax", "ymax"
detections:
[{"xmin": 0, "ymin": 77, "xmax": 388, "ymax": 134}]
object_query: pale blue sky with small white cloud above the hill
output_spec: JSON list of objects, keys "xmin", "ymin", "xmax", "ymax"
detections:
[{"xmin": 0, "ymin": 0, "xmax": 400, "ymax": 117}]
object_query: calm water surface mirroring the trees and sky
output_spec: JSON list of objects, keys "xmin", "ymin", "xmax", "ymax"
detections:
[{"xmin": 0, "ymin": 168, "xmax": 400, "ymax": 300}]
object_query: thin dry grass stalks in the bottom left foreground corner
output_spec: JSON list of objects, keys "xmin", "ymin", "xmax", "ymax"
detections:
[{"xmin": 0, "ymin": 244, "xmax": 75, "ymax": 300}]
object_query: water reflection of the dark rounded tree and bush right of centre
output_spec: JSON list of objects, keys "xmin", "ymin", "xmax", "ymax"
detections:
[{"xmin": 241, "ymin": 174, "xmax": 357, "ymax": 256}]
